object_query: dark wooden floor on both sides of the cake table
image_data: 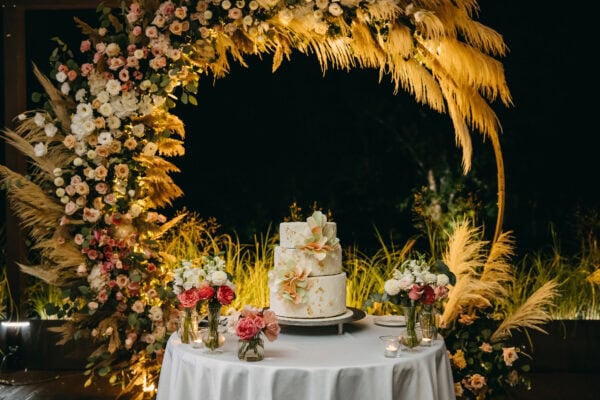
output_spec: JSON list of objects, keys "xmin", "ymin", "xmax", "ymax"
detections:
[{"xmin": 0, "ymin": 371, "xmax": 600, "ymax": 400}]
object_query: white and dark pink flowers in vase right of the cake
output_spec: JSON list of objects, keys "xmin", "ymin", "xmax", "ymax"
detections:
[{"xmin": 381, "ymin": 256, "xmax": 456, "ymax": 306}]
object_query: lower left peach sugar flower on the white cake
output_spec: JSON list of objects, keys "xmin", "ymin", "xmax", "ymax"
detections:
[{"xmin": 269, "ymin": 259, "xmax": 312, "ymax": 304}]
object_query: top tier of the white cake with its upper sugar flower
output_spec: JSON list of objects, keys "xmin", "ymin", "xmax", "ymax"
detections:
[{"xmin": 279, "ymin": 211, "xmax": 339, "ymax": 251}]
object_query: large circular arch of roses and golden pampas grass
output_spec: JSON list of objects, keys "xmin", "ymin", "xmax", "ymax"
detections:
[{"xmin": 0, "ymin": 0, "xmax": 511, "ymax": 394}]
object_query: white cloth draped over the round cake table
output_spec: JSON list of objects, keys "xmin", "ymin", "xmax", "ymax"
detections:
[{"xmin": 157, "ymin": 315, "xmax": 455, "ymax": 400}]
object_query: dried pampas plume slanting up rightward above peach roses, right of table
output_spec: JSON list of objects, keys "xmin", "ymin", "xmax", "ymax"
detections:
[{"xmin": 490, "ymin": 280, "xmax": 558, "ymax": 343}]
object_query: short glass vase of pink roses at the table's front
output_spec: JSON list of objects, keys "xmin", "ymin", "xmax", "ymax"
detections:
[{"xmin": 231, "ymin": 305, "xmax": 281, "ymax": 361}]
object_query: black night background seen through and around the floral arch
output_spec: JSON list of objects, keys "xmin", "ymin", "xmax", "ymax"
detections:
[{"xmin": 0, "ymin": 0, "xmax": 599, "ymax": 251}]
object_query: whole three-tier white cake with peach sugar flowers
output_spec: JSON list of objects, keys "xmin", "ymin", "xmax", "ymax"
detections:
[{"xmin": 269, "ymin": 211, "xmax": 347, "ymax": 318}]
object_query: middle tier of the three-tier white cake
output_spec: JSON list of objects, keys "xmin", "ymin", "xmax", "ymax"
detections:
[{"xmin": 273, "ymin": 246, "xmax": 342, "ymax": 276}]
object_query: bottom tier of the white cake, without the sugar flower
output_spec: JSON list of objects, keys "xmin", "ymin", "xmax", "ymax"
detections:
[{"xmin": 269, "ymin": 272, "xmax": 347, "ymax": 318}]
